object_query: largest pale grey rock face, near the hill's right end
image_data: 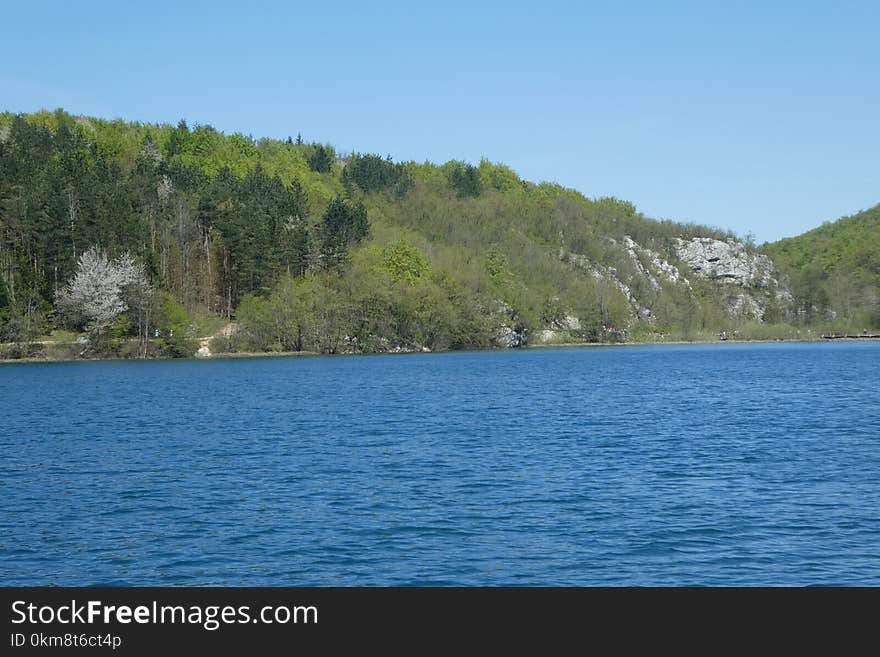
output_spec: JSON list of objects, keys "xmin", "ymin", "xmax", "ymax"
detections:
[{"xmin": 675, "ymin": 237, "xmax": 774, "ymax": 288}]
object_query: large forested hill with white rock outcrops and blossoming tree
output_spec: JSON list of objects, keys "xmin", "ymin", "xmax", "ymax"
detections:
[{"xmin": 0, "ymin": 110, "xmax": 868, "ymax": 356}]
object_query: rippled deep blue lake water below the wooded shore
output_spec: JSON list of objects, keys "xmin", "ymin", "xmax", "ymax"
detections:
[{"xmin": 0, "ymin": 343, "xmax": 880, "ymax": 585}]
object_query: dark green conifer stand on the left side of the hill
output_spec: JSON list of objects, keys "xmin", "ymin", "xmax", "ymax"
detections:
[{"xmin": 0, "ymin": 112, "xmax": 368, "ymax": 348}]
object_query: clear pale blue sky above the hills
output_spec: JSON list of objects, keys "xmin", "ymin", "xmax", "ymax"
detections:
[{"xmin": 0, "ymin": 0, "xmax": 880, "ymax": 241}]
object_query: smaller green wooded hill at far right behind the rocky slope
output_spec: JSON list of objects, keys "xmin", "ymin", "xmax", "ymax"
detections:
[{"xmin": 764, "ymin": 205, "xmax": 880, "ymax": 330}]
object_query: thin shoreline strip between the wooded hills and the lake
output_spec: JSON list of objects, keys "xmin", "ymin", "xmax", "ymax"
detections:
[{"xmin": 0, "ymin": 336, "xmax": 880, "ymax": 365}]
